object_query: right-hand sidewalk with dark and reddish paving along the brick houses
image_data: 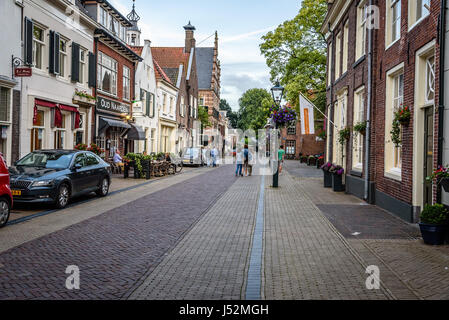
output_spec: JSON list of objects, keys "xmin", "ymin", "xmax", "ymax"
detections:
[{"xmin": 286, "ymin": 161, "xmax": 449, "ymax": 299}]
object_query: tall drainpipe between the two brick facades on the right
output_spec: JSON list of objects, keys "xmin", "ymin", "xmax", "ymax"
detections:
[{"xmin": 364, "ymin": 0, "xmax": 373, "ymax": 202}]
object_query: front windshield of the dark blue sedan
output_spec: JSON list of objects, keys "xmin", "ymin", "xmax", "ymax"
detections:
[{"xmin": 17, "ymin": 152, "xmax": 73, "ymax": 169}]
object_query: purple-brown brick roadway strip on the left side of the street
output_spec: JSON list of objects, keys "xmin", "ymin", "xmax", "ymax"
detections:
[{"xmin": 0, "ymin": 167, "xmax": 236, "ymax": 299}]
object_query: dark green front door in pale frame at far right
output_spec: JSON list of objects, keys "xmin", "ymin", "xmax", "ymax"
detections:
[{"xmin": 424, "ymin": 108, "xmax": 434, "ymax": 205}]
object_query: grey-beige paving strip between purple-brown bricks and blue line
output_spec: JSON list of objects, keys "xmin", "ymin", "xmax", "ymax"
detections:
[{"xmin": 130, "ymin": 172, "xmax": 260, "ymax": 300}]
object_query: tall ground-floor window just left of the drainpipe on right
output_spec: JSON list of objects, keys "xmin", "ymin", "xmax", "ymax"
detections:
[{"xmin": 352, "ymin": 88, "xmax": 365, "ymax": 170}]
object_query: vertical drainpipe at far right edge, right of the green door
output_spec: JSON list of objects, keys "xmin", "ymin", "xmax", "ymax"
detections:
[{"xmin": 437, "ymin": 0, "xmax": 446, "ymax": 203}]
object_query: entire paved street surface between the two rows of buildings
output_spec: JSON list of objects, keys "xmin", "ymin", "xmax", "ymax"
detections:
[{"xmin": 0, "ymin": 161, "xmax": 449, "ymax": 300}]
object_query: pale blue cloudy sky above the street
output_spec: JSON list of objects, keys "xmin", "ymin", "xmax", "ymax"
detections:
[{"xmin": 109, "ymin": 0, "xmax": 301, "ymax": 111}]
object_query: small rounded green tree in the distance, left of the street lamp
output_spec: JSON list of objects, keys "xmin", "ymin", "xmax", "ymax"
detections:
[{"xmin": 237, "ymin": 89, "xmax": 272, "ymax": 132}]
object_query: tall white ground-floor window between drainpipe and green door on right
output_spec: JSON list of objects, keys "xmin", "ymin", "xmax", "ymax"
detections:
[{"xmin": 384, "ymin": 64, "xmax": 404, "ymax": 180}]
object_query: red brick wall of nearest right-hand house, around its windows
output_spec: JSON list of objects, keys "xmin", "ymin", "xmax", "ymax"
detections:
[{"xmin": 370, "ymin": 0, "xmax": 440, "ymax": 204}]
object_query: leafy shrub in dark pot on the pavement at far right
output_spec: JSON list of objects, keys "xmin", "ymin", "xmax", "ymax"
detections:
[{"xmin": 419, "ymin": 204, "xmax": 449, "ymax": 245}]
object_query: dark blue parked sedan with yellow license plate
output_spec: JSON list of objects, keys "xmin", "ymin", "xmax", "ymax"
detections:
[{"xmin": 9, "ymin": 150, "xmax": 111, "ymax": 208}]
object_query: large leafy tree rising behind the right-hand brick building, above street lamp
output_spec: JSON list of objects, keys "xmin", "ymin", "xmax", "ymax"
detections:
[{"xmin": 260, "ymin": 0, "xmax": 327, "ymax": 118}]
